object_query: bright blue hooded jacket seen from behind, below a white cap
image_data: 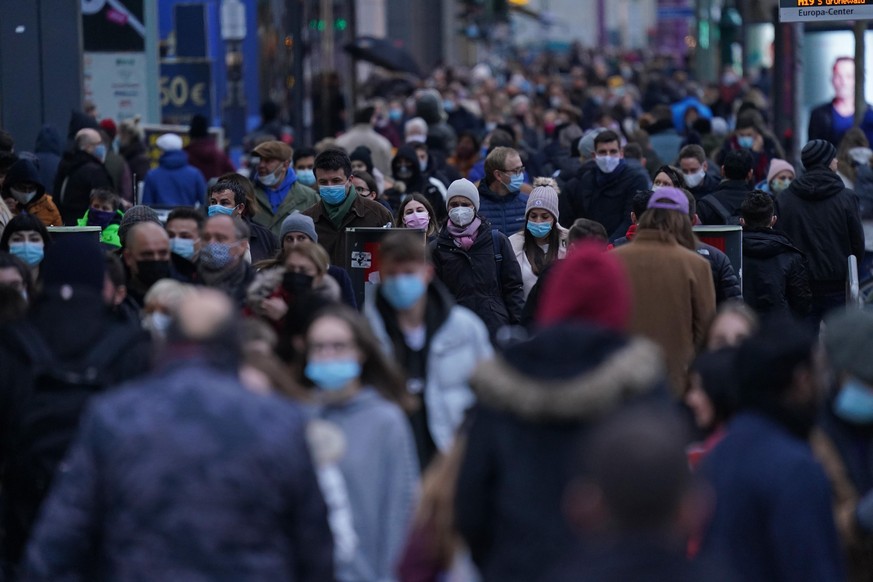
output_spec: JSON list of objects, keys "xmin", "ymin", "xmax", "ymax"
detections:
[{"xmin": 142, "ymin": 150, "xmax": 206, "ymax": 206}]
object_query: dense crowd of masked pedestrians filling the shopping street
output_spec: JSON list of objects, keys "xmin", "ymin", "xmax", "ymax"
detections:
[{"xmin": 0, "ymin": 52, "xmax": 873, "ymax": 582}]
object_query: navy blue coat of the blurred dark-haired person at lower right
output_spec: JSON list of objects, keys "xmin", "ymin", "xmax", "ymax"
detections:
[{"xmin": 700, "ymin": 412, "xmax": 845, "ymax": 582}]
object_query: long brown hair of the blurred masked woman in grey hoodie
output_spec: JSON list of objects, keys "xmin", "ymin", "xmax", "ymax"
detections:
[{"xmin": 304, "ymin": 304, "xmax": 412, "ymax": 410}]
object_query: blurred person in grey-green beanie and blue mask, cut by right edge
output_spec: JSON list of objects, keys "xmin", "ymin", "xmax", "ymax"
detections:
[{"xmin": 812, "ymin": 311, "xmax": 873, "ymax": 582}]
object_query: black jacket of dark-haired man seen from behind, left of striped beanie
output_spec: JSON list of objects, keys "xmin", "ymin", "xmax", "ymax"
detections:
[{"xmin": 743, "ymin": 228, "xmax": 812, "ymax": 317}]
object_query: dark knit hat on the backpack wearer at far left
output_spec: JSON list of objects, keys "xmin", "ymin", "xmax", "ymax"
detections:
[{"xmin": 40, "ymin": 234, "xmax": 106, "ymax": 293}]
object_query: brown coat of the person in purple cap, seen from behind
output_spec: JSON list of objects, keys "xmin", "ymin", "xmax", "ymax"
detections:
[{"xmin": 612, "ymin": 230, "xmax": 715, "ymax": 397}]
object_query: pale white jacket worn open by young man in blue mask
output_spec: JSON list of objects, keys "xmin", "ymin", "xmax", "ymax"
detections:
[{"xmin": 364, "ymin": 292, "xmax": 494, "ymax": 452}]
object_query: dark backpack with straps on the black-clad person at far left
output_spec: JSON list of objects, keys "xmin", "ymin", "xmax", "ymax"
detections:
[{"xmin": 4, "ymin": 324, "xmax": 143, "ymax": 560}]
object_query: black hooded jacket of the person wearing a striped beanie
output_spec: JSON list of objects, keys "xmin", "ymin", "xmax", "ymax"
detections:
[{"xmin": 776, "ymin": 166, "xmax": 864, "ymax": 294}]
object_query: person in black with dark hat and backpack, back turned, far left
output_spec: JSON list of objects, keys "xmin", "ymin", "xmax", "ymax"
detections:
[{"xmin": 0, "ymin": 237, "xmax": 151, "ymax": 576}]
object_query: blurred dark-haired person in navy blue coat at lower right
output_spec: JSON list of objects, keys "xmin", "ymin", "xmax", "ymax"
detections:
[{"xmin": 700, "ymin": 319, "xmax": 844, "ymax": 582}]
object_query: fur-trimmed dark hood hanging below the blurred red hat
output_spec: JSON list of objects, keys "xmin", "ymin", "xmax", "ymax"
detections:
[{"xmin": 471, "ymin": 325, "xmax": 666, "ymax": 422}]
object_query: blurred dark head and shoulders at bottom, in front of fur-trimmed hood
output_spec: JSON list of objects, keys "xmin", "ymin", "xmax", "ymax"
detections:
[{"xmin": 545, "ymin": 407, "xmax": 727, "ymax": 582}]
